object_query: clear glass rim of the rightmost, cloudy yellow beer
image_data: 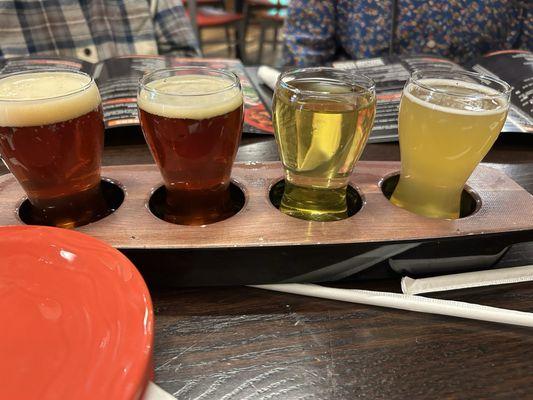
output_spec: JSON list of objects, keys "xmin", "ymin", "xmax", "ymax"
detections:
[{"xmin": 407, "ymin": 68, "xmax": 512, "ymax": 99}]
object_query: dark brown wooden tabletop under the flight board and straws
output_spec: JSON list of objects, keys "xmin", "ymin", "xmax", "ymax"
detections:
[{"xmin": 96, "ymin": 126, "xmax": 533, "ymax": 400}]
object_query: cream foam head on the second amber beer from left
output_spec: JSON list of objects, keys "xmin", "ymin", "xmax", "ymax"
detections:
[{"xmin": 137, "ymin": 75, "xmax": 243, "ymax": 120}]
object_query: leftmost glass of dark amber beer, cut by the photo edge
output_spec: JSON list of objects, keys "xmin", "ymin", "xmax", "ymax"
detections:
[{"xmin": 0, "ymin": 70, "xmax": 106, "ymax": 228}]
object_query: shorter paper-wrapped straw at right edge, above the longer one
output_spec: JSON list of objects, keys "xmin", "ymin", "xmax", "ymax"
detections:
[{"xmin": 402, "ymin": 265, "xmax": 533, "ymax": 294}]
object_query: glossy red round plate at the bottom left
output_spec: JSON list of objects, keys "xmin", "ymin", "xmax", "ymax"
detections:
[{"xmin": 0, "ymin": 226, "xmax": 153, "ymax": 400}]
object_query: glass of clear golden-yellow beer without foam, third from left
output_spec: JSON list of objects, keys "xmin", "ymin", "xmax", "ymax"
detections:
[{"xmin": 273, "ymin": 68, "xmax": 376, "ymax": 221}]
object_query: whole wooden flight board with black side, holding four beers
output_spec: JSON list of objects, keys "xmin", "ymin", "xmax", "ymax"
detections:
[{"xmin": 0, "ymin": 161, "xmax": 533, "ymax": 285}]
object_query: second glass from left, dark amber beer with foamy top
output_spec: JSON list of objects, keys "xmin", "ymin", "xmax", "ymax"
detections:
[{"xmin": 137, "ymin": 67, "xmax": 243, "ymax": 225}]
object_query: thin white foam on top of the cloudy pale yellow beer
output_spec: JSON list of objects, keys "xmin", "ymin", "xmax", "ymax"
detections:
[{"xmin": 402, "ymin": 78, "xmax": 508, "ymax": 116}]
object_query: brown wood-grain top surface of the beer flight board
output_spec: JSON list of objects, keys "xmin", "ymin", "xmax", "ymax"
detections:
[{"xmin": 0, "ymin": 161, "xmax": 533, "ymax": 251}]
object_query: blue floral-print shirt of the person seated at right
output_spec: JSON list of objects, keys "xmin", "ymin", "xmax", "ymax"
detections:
[{"xmin": 284, "ymin": 0, "xmax": 533, "ymax": 66}]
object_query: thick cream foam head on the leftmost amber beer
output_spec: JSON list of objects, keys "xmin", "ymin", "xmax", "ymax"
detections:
[{"xmin": 0, "ymin": 71, "xmax": 100, "ymax": 127}]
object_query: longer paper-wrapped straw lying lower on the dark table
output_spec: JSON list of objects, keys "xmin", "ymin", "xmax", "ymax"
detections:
[{"xmin": 252, "ymin": 283, "xmax": 533, "ymax": 327}]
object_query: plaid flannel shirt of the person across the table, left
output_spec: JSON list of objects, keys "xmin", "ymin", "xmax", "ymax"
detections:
[{"xmin": 0, "ymin": 0, "xmax": 200, "ymax": 62}]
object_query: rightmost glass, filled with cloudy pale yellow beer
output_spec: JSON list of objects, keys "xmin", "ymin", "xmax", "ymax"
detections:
[{"xmin": 391, "ymin": 71, "xmax": 510, "ymax": 218}]
